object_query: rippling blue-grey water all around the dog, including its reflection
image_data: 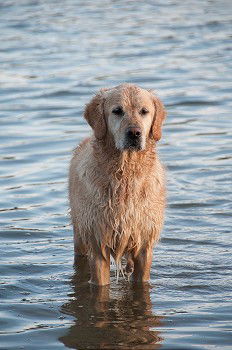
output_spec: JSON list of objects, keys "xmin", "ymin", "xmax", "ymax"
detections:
[{"xmin": 0, "ymin": 0, "xmax": 232, "ymax": 350}]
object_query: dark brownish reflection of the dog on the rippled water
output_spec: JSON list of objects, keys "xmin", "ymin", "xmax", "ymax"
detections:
[{"xmin": 59, "ymin": 261, "xmax": 163, "ymax": 349}]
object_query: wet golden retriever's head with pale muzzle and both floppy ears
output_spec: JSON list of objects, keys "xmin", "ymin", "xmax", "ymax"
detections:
[{"xmin": 84, "ymin": 84, "xmax": 166, "ymax": 151}]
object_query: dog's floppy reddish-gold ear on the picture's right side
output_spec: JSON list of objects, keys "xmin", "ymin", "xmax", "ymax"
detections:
[{"xmin": 150, "ymin": 91, "xmax": 166, "ymax": 141}]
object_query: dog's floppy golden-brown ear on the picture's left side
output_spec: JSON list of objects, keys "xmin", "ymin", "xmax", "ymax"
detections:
[{"xmin": 84, "ymin": 89, "xmax": 107, "ymax": 139}]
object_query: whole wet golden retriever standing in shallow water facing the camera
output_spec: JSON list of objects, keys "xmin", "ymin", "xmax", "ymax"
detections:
[{"xmin": 69, "ymin": 83, "xmax": 166, "ymax": 286}]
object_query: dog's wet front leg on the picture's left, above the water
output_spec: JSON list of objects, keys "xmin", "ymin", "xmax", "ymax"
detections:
[{"xmin": 89, "ymin": 248, "xmax": 110, "ymax": 286}]
